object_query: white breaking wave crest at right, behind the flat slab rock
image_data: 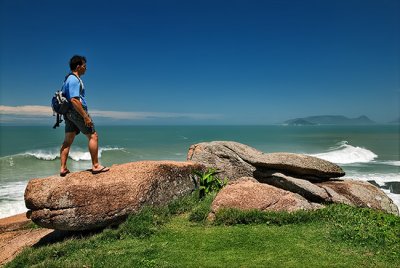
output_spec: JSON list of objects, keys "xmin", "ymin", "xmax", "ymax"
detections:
[{"xmin": 312, "ymin": 141, "xmax": 378, "ymax": 164}]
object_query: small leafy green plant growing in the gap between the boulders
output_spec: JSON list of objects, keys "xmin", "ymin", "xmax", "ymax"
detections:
[{"xmin": 194, "ymin": 168, "xmax": 228, "ymax": 199}]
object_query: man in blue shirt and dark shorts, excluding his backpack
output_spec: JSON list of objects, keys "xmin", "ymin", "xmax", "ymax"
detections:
[{"xmin": 60, "ymin": 55, "xmax": 110, "ymax": 177}]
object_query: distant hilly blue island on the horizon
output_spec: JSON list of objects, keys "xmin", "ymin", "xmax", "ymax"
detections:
[{"xmin": 283, "ymin": 115, "xmax": 376, "ymax": 126}]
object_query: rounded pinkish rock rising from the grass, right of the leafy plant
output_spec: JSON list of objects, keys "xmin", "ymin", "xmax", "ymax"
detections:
[{"xmin": 211, "ymin": 177, "xmax": 323, "ymax": 218}]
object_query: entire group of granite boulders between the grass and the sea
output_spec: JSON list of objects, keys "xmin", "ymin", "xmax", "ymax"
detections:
[{"xmin": 25, "ymin": 142, "xmax": 399, "ymax": 231}]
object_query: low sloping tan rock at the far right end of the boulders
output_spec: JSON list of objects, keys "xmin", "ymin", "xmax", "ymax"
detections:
[{"xmin": 316, "ymin": 179, "xmax": 399, "ymax": 215}]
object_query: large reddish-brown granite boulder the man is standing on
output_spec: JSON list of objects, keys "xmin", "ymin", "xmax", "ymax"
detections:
[{"xmin": 25, "ymin": 161, "xmax": 205, "ymax": 230}]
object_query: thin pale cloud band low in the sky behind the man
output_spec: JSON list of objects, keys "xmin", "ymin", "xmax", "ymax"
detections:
[{"xmin": 0, "ymin": 105, "xmax": 222, "ymax": 121}]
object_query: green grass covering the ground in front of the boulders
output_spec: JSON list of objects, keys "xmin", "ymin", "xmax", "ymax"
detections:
[{"xmin": 7, "ymin": 195, "xmax": 400, "ymax": 267}]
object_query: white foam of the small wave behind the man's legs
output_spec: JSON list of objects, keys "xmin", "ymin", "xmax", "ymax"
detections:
[{"xmin": 20, "ymin": 147, "xmax": 124, "ymax": 161}]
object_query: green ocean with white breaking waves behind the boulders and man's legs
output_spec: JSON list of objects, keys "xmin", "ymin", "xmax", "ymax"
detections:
[{"xmin": 0, "ymin": 125, "xmax": 400, "ymax": 218}]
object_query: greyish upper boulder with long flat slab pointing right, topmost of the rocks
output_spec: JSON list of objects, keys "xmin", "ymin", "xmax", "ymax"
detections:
[{"xmin": 187, "ymin": 141, "xmax": 345, "ymax": 181}]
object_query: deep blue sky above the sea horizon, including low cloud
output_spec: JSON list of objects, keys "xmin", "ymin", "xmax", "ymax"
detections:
[{"xmin": 0, "ymin": 0, "xmax": 400, "ymax": 124}]
